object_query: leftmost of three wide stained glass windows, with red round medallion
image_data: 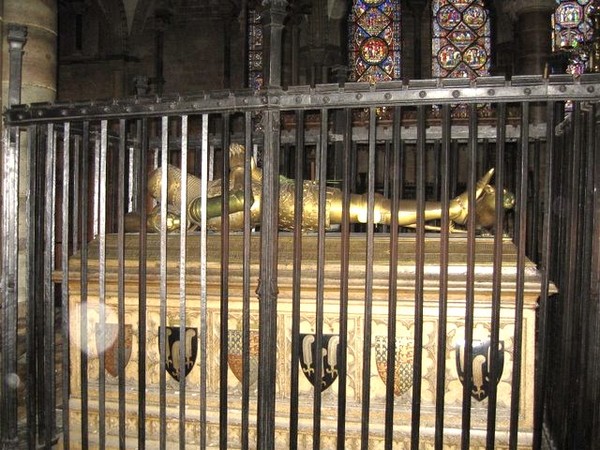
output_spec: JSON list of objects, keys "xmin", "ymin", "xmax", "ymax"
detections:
[{"xmin": 348, "ymin": 0, "xmax": 401, "ymax": 83}]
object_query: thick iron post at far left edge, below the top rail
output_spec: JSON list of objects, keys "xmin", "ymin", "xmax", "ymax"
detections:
[{"xmin": 0, "ymin": 127, "xmax": 20, "ymax": 448}]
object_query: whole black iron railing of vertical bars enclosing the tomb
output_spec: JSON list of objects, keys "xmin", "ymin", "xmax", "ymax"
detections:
[{"xmin": 0, "ymin": 75, "xmax": 600, "ymax": 449}]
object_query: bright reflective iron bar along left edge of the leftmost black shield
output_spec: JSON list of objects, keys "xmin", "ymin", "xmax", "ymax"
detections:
[{"xmin": 158, "ymin": 116, "xmax": 169, "ymax": 448}]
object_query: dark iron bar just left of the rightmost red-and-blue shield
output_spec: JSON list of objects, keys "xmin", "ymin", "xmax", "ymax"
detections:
[{"xmin": 360, "ymin": 107, "xmax": 377, "ymax": 450}]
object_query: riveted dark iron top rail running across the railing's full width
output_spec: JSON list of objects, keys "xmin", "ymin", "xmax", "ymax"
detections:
[{"xmin": 6, "ymin": 74, "xmax": 600, "ymax": 124}]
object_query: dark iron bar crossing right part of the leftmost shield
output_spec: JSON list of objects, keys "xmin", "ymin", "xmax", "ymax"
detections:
[{"xmin": 116, "ymin": 119, "xmax": 127, "ymax": 449}]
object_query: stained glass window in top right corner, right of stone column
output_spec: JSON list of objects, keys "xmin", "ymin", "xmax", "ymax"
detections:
[{"xmin": 552, "ymin": 0, "xmax": 594, "ymax": 75}]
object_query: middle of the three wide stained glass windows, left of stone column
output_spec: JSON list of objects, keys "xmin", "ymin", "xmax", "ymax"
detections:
[{"xmin": 432, "ymin": 0, "xmax": 491, "ymax": 78}]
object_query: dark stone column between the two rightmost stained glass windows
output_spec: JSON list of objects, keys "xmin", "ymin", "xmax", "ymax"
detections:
[{"xmin": 504, "ymin": 0, "xmax": 556, "ymax": 75}]
